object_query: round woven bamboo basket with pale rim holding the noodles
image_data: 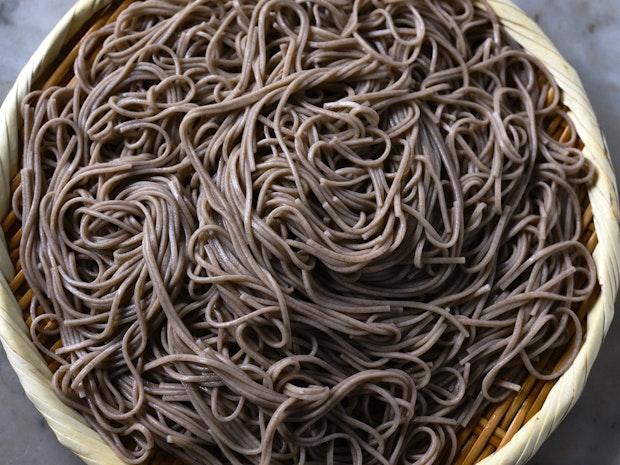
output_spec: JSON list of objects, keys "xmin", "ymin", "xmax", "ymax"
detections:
[{"xmin": 0, "ymin": 0, "xmax": 620, "ymax": 465}]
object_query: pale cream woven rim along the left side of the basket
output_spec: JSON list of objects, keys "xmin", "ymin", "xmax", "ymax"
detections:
[{"xmin": 0, "ymin": 0, "xmax": 124, "ymax": 465}]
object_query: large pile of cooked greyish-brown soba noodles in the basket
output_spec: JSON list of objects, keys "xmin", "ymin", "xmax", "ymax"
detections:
[{"xmin": 15, "ymin": 0, "xmax": 596, "ymax": 465}]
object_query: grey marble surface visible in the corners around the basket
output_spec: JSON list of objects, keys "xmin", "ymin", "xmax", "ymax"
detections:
[{"xmin": 0, "ymin": 0, "xmax": 620, "ymax": 465}]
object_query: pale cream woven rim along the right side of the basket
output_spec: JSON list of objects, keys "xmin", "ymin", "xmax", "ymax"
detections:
[{"xmin": 479, "ymin": 0, "xmax": 620, "ymax": 465}]
